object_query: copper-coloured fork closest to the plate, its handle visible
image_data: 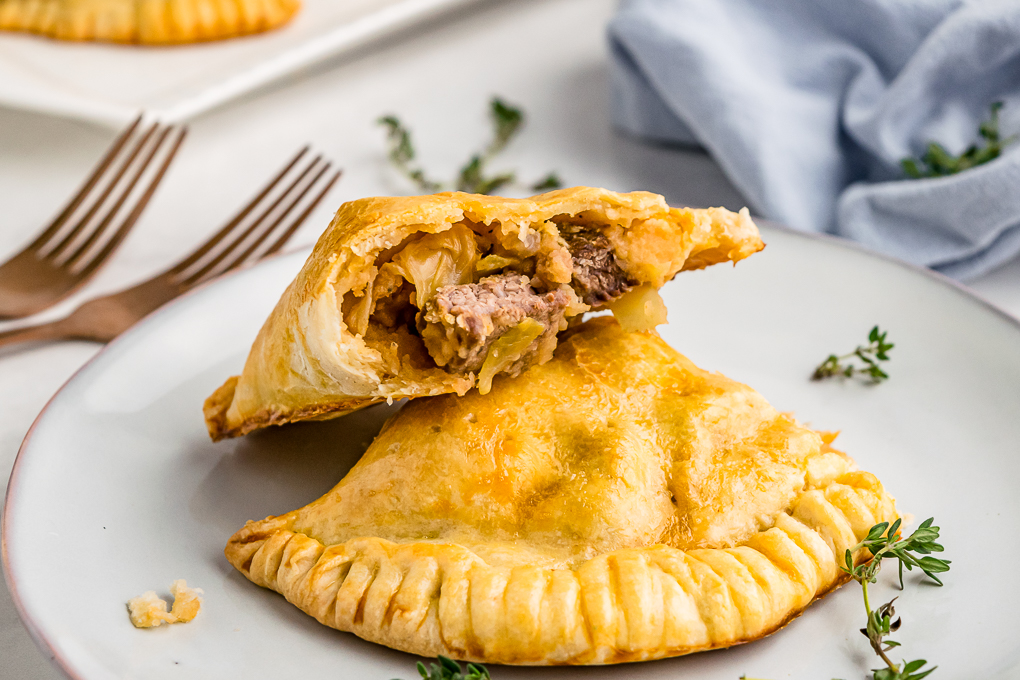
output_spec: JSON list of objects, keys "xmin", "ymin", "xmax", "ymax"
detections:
[{"xmin": 0, "ymin": 147, "xmax": 341, "ymax": 346}]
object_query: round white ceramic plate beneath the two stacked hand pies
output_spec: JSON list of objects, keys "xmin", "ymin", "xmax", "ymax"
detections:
[{"xmin": 3, "ymin": 229, "xmax": 1020, "ymax": 680}]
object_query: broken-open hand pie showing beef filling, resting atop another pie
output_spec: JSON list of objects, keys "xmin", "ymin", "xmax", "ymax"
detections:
[{"xmin": 205, "ymin": 188, "xmax": 764, "ymax": 439}]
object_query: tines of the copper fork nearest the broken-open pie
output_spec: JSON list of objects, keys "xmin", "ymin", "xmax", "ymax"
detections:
[{"xmin": 169, "ymin": 147, "xmax": 341, "ymax": 287}]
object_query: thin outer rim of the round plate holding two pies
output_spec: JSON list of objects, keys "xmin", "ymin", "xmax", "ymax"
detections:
[{"xmin": 0, "ymin": 226, "xmax": 1020, "ymax": 680}]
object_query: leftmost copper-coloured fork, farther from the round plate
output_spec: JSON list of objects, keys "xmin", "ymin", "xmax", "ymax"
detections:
[{"xmin": 0, "ymin": 116, "xmax": 188, "ymax": 318}]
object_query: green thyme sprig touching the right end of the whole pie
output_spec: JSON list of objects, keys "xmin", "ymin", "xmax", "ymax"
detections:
[{"xmin": 839, "ymin": 517, "xmax": 950, "ymax": 680}]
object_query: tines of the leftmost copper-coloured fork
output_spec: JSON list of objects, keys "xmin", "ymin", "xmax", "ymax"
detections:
[{"xmin": 31, "ymin": 116, "xmax": 188, "ymax": 272}]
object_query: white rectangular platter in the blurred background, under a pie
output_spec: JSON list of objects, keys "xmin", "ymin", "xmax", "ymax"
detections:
[{"xmin": 0, "ymin": 0, "xmax": 476, "ymax": 125}]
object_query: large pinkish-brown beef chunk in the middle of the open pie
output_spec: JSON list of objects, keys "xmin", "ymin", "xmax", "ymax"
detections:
[{"xmin": 421, "ymin": 273, "xmax": 569, "ymax": 371}]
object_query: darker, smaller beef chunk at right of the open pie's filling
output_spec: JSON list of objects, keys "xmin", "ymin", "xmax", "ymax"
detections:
[{"xmin": 560, "ymin": 224, "xmax": 638, "ymax": 308}]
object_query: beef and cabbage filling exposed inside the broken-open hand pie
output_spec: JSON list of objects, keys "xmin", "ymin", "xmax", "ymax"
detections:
[{"xmin": 359, "ymin": 222, "xmax": 648, "ymax": 385}]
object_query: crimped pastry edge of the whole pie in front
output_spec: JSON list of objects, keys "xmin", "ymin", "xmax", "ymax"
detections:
[{"xmin": 224, "ymin": 471, "xmax": 898, "ymax": 665}]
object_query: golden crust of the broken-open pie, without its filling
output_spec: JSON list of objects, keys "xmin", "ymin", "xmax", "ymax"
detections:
[{"xmin": 206, "ymin": 188, "xmax": 764, "ymax": 439}]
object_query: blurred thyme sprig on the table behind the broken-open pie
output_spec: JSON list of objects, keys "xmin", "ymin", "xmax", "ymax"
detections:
[{"xmin": 378, "ymin": 97, "xmax": 562, "ymax": 194}]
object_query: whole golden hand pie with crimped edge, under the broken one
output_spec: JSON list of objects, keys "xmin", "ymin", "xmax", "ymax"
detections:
[{"xmin": 225, "ymin": 318, "xmax": 897, "ymax": 664}]
